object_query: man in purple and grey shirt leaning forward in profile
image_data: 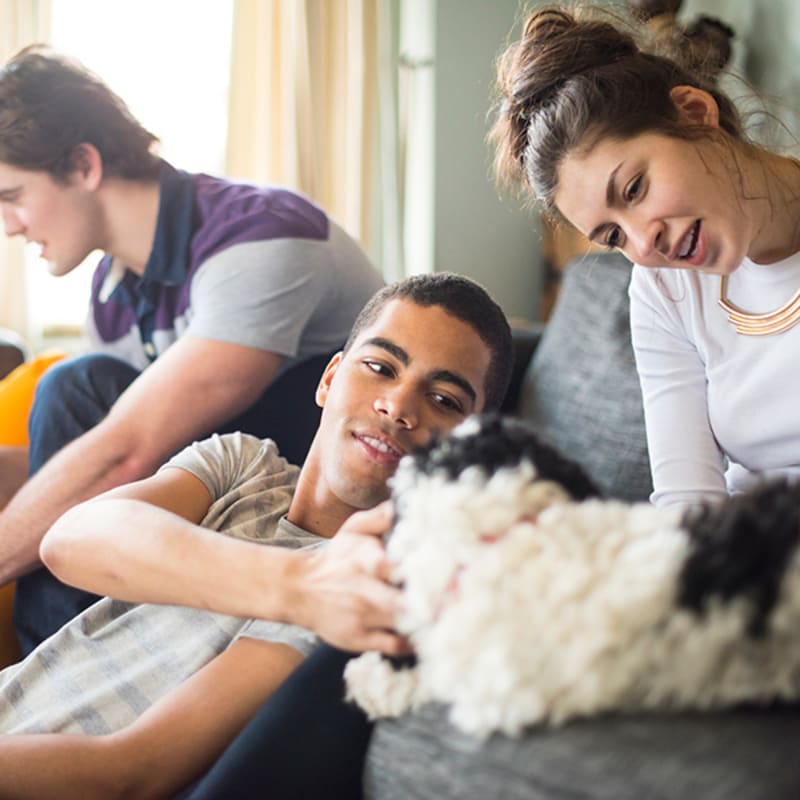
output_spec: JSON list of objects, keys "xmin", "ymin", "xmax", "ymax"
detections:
[{"xmin": 0, "ymin": 48, "xmax": 382, "ymax": 653}]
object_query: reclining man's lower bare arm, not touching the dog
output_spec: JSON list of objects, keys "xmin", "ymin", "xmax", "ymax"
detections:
[{"xmin": 0, "ymin": 638, "xmax": 302, "ymax": 800}]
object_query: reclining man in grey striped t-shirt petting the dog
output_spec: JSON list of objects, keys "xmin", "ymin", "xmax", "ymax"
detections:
[{"xmin": 0, "ymin": 275, "xmax": 511, "ymax": 799}]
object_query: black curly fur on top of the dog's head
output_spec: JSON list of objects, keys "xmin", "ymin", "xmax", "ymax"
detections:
[{"xmin": 412, "ymin": 414, "xmax": 600, "ymax": 500}]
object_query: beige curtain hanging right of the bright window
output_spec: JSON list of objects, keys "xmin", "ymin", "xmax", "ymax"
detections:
[{"xmin": 226, "ymin": 0, "xmax": 399, "ymax": 272}]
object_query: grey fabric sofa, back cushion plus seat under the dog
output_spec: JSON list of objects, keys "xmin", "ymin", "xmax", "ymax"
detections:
[{"xmin": 364, "ymin": 254, "xmax": 800, "ymax": 800}]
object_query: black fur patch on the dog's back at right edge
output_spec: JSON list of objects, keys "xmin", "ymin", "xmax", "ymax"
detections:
[{"xmin": 679, "ymin": 480, "xmax": 800, "ymax": 636}]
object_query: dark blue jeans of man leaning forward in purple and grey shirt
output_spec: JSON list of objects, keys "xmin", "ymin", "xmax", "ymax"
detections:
[{"xmin": 14, "ymin": 354, "xmax": 331, "ymax": 656}]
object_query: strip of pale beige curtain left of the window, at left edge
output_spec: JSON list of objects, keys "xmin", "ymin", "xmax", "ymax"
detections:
[{"xmin": 0, "ymin": 0, "xmax": 51, "ymax": 337}]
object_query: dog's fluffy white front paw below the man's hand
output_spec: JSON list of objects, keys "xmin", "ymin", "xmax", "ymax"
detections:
[{"xmin": 344, "ymin": 653, "xmax": 417, "ymax": 719}]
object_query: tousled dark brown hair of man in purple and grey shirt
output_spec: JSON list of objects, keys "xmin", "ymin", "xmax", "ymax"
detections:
[{"xmin": 0, "ymin": 45, "xmax": 160, "ymax": 183}]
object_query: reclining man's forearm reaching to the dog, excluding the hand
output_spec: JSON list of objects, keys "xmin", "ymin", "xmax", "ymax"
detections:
[{"xmin": 41, "ymin": 496, "xmax": 298, "ymax": 620}]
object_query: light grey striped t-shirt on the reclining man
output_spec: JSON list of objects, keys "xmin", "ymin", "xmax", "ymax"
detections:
[{"xmin": 0, "ymin": 433, "xmax": 324, "ymax": 734}]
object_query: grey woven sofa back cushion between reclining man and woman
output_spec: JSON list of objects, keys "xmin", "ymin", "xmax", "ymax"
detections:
[{"xmin": 518, "ymin": 253, "xmax": 652, "ymax": 500}]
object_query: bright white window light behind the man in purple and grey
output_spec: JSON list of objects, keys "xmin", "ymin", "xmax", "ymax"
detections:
[{"xmin": 26, "ymin": 0, "xmax": 233, "ymax": 346}]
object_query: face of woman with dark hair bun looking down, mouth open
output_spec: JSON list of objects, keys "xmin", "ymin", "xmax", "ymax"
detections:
[{"xmin": 555, "ymin": 126, "xmax": 756, "ymax": 275}]
